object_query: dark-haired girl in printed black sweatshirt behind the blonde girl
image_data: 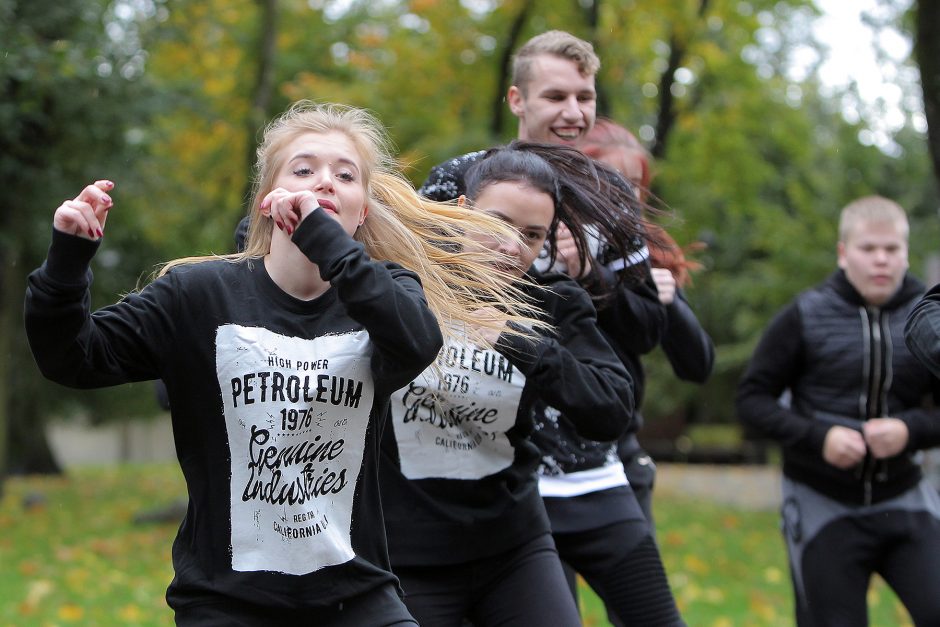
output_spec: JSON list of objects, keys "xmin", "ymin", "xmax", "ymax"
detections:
[{"xmin": 381, "ymin": 143, "xmax": 640, "ymax": 627}]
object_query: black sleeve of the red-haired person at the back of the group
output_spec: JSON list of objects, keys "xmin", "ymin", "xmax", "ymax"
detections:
[{"xmin": 660, "ymin": 290, "xmax": 715, "ymax": 383}]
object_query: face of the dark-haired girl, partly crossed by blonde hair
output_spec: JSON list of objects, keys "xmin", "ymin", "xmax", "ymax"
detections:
[{"xmin": 464, "ymin": 181, "xmax": 555, "ymax": 277}]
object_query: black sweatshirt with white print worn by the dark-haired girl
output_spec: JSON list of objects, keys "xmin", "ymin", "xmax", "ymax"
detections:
[{"xmin": 382, "ymin": 272, "xmax": 633, "ymax": 566}]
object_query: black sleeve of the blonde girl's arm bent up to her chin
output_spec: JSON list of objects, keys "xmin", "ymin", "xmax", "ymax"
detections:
[{"xmin": 292, "ymin": 210, "xmax": 443, "ymax": 389}]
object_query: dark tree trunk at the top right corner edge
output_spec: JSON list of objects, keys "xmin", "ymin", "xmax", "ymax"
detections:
[{"xmin": 915, "ymin": 0, "xmax": 940, "ymax": 187}]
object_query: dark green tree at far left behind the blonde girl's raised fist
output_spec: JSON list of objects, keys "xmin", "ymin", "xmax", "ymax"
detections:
[{"xmin": 0, "ymin": 0, "xmax": 162, "ymax": 472}]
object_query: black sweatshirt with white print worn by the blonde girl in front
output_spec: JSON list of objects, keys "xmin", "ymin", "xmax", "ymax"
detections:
[{"xmin": 26, "ymin": 211, "xmax": 442, "ymax": 609}]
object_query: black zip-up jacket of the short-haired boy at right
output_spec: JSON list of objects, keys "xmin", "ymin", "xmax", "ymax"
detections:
[{"xmin": 737, "ymin": 270, "xmax": 940, "ymax": 504}]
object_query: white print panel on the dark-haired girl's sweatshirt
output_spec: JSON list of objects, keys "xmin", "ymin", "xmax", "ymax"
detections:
[{"xmin": 392, "ymin": 343, "xmax": 525, "ymax": 479}]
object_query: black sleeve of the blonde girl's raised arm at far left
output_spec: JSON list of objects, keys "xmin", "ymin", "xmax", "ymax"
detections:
[{"xmin": 24, "ymin": 230, "xmax": 173, "ymax": 388}]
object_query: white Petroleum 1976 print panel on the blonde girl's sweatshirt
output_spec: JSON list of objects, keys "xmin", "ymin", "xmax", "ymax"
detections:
[{"xmin": 216, "ymin": 325, "xmax": 375, "ymax": 575}]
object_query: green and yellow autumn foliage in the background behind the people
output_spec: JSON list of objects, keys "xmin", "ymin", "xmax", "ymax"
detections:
[{"xmin": 0, "ymin": 0, "xmax": 940, "ymax": 466}]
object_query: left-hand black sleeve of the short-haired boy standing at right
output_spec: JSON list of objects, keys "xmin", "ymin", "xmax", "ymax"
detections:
[{"xmin": 736, "ymin": 304, "xmax": 829, "ymax": 455}]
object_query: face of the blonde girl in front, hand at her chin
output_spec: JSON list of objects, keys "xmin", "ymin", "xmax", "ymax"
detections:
[{"xmin": 274, "ymin": 131, "xmax": 368, "ymax": 235}]
